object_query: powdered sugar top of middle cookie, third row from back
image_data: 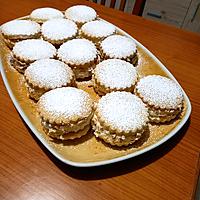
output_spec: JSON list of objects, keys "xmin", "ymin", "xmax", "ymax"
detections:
[{"xmin": 58, "ymin": 39, "xmax": 97, "ymax": 65}]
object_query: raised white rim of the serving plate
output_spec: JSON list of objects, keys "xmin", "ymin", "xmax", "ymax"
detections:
[{"xmin": 0, "ymin": 22, "xmax": 192, "ymax": 167}]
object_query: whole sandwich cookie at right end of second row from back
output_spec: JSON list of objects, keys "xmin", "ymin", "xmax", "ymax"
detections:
[{"xmin": 80, "ymin": 20, "xmax": 116, "ymax": 44}]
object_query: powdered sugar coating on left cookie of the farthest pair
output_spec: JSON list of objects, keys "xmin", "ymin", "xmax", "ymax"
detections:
[{"xmin": 30, "ymin": 7, "xmax": 64, "ymax": 21}]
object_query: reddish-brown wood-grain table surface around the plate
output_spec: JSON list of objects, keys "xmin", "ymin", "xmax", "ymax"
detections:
[{"xmin": 0, "ymin": 0, "xmax": 200, "ymax": 200}]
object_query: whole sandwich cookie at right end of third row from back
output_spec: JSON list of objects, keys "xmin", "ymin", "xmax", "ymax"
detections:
[{"xmin": 100, "ymin": 35, "xmax": 138, "ymax": 65}]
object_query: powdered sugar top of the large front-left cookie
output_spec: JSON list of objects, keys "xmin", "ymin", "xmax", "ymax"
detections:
[{"xmin": 38, "ymin": 87, "xmax": 92, "ymax": 119}]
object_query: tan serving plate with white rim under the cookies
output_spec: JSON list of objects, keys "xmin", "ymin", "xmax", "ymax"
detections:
[{"xmin": 0, "ymin": 17, "xmax": 191, "ymax": 167}]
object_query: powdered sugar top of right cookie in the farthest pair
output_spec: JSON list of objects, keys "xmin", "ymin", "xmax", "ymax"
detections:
[{"xmin": 65, "ymin": 5, "xmax": 97, "ymax": 23}]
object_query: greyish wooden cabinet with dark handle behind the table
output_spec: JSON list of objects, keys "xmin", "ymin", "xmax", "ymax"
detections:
[{"xmin": 143, "ymin": 0, "xmax": 200, "ymax": 32}]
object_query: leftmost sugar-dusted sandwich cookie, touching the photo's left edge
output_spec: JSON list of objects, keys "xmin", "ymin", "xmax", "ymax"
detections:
[{"xmin": 1, "ymin": 20, "xmax": 40, "ymax": 48}]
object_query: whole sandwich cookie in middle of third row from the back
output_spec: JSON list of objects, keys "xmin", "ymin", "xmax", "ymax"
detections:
[{"xmin": 57, "ymin": 39, "xmax": 98, "ymax": 79}]
